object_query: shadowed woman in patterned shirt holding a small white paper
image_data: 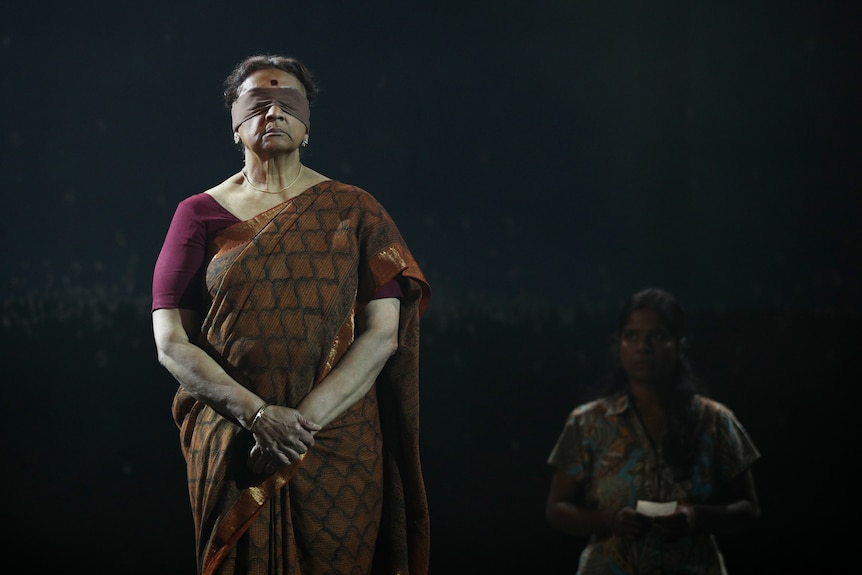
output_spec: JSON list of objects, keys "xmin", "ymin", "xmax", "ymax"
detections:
[{"xmin": 546, "ymin": 289, "xmax": 760, "ymax": 575}]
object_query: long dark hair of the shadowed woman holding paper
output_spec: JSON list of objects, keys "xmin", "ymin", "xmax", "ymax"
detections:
[{"xmin": 604, "ymin": 288, "xmax": 704, "ymax": 480}]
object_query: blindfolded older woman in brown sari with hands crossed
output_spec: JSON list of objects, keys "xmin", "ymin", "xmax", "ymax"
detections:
[{"xmin": 152, "ymin": 55, "xmax": 430, "ymax": 575}]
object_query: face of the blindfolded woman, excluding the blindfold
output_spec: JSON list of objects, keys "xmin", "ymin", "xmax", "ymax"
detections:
[{"xmin": 237, "ymin": 68, "xmax": 307, "ymax": 154}]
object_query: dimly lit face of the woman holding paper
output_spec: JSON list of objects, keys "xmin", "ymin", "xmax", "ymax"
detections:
[{"xmin": 619, "ymin": 309, "xmax": 679, "ymax": 385}]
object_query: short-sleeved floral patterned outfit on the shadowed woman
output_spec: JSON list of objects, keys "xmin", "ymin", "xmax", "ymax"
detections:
[{"xmin": 548, "ymin": 392, "xmax": 760, "ymax": 575}]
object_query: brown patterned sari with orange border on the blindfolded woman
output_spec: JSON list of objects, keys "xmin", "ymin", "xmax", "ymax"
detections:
[{"xmin": 173, "ymin": 181, "xmax": 430, "ymax": 574}]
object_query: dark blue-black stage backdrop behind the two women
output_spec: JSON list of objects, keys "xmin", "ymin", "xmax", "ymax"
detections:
[{"xmin": 0, "ymin": 0, "xmax": 862, "ymax": 575}]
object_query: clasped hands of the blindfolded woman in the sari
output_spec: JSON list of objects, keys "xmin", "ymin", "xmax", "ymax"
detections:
[{"xmin": 248, "ymin": 405, "xmax": 320, "ymax": 473}]
